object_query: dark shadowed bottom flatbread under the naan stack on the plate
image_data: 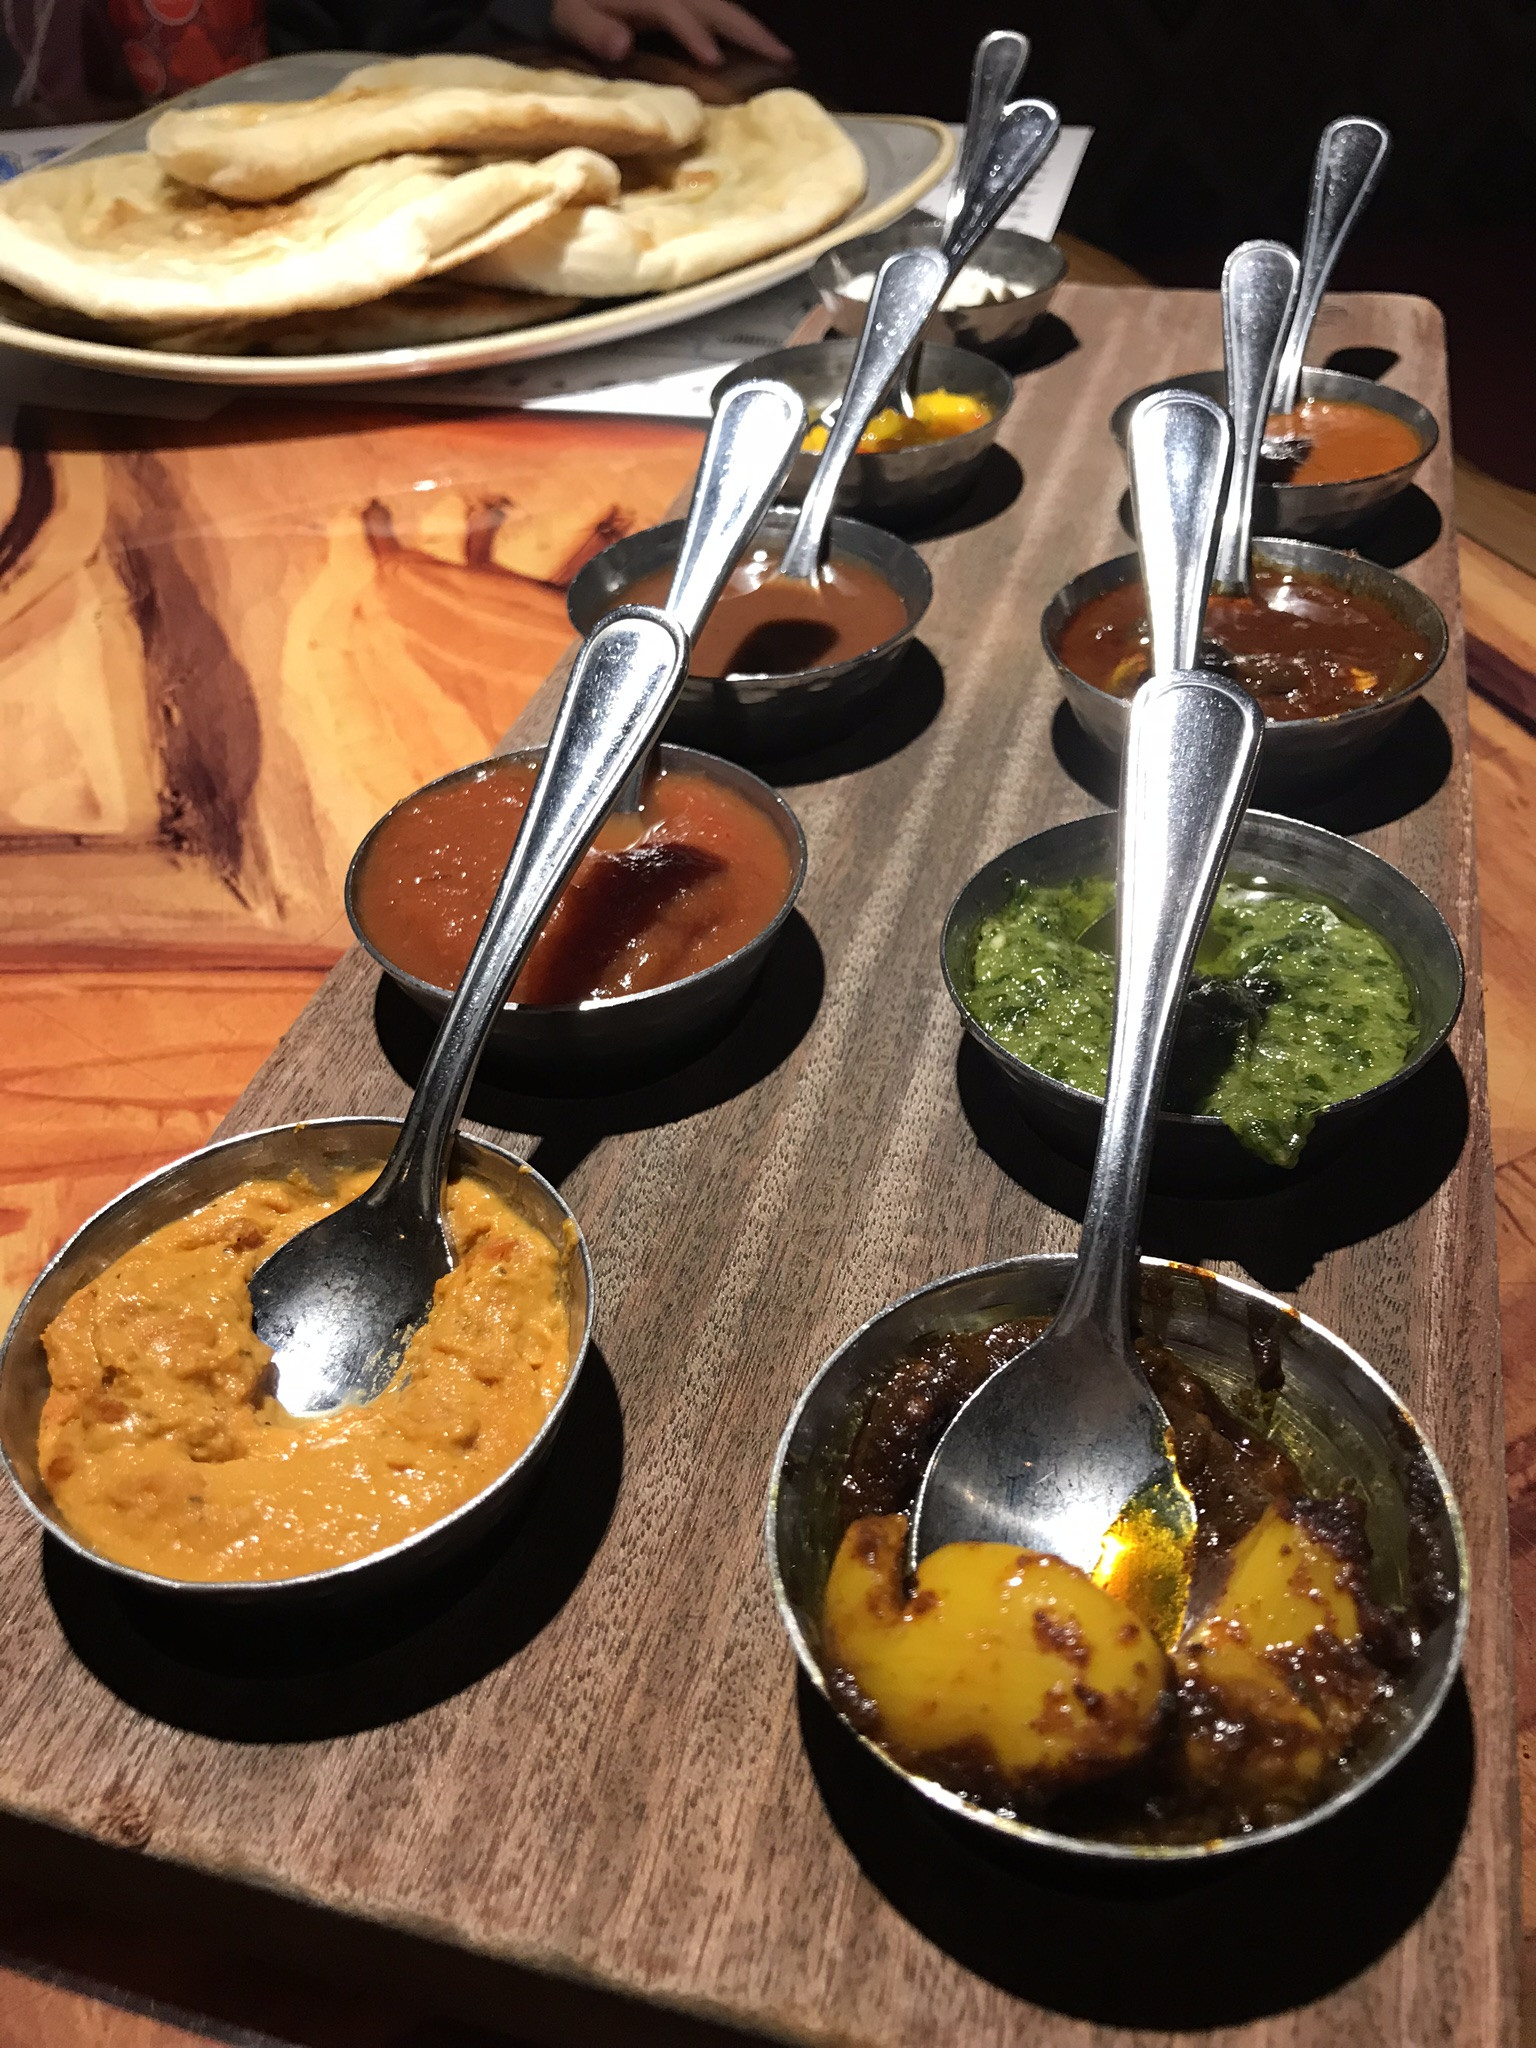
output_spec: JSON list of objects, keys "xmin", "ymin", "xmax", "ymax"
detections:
[{"xmin": 121, "ymin": 279, "xmax": 582, "ymax": 356}]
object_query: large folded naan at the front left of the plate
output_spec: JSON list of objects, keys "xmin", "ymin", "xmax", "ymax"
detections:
[{"xmin": 0, "ymin": 150, "xmax": 618, "ymax": 326}]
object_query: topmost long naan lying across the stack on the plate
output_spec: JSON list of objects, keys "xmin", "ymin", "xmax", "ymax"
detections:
[{"xmin": 147, "ymin": 57, "xmax": 705, "ymax": 199}]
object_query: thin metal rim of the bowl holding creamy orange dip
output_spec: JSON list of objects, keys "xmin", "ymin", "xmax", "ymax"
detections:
[{"xmin": 0, "ymin": 1116, "xmax": 596, "ymax": 1599}]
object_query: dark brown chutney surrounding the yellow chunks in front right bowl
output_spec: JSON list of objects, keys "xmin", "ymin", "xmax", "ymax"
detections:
[{"xmin": 829, "ymin": 1317, "xmax": 1444, "ymax": 1845}]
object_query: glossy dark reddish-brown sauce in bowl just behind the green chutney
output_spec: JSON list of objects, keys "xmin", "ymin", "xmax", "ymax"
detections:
[{"xmin": 1059, "ymin": 563, "xmax": 1430, "ymax": 719}]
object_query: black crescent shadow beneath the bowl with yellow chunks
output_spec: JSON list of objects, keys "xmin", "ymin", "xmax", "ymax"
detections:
[{"xmin": 801, "ymin": 1679, "xmax": 1473, "ymax": 2032}]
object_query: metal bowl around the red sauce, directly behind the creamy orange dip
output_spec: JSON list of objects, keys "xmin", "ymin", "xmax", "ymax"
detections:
[{"xmin": 346, "ymin": 745, "xmax": 807, "ymax": 1081}]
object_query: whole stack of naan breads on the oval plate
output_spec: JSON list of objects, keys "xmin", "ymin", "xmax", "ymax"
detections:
[{"xmin": 0, "ymin": 57, "xmax": 864, "ymax": 354}]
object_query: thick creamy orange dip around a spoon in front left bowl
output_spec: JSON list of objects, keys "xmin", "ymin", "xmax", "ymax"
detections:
[{"xmin": 37, "ymin": 1167, "xmax": 571, "ymax": 1581}]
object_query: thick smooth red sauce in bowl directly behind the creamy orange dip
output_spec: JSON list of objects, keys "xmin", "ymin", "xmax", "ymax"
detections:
[{"xmin": 352, "ymin": 760, "xmax": 793, "ymax": 1004}]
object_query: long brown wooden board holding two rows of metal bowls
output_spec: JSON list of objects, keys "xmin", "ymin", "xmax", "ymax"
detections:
[{"xmin": 0, "ymin": 289, "xmax": 1518, "ymax": 2048}]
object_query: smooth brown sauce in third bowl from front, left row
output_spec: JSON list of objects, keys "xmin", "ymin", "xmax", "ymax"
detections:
[{"xmin": 614, "ymin": 549, "xmax": 907, "ymax": 676}]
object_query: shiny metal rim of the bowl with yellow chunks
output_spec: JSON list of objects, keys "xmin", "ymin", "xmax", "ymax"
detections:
[{"xmin": 764, "ymin": 1251, "xmax": 1470, "ymax": 1864}]
